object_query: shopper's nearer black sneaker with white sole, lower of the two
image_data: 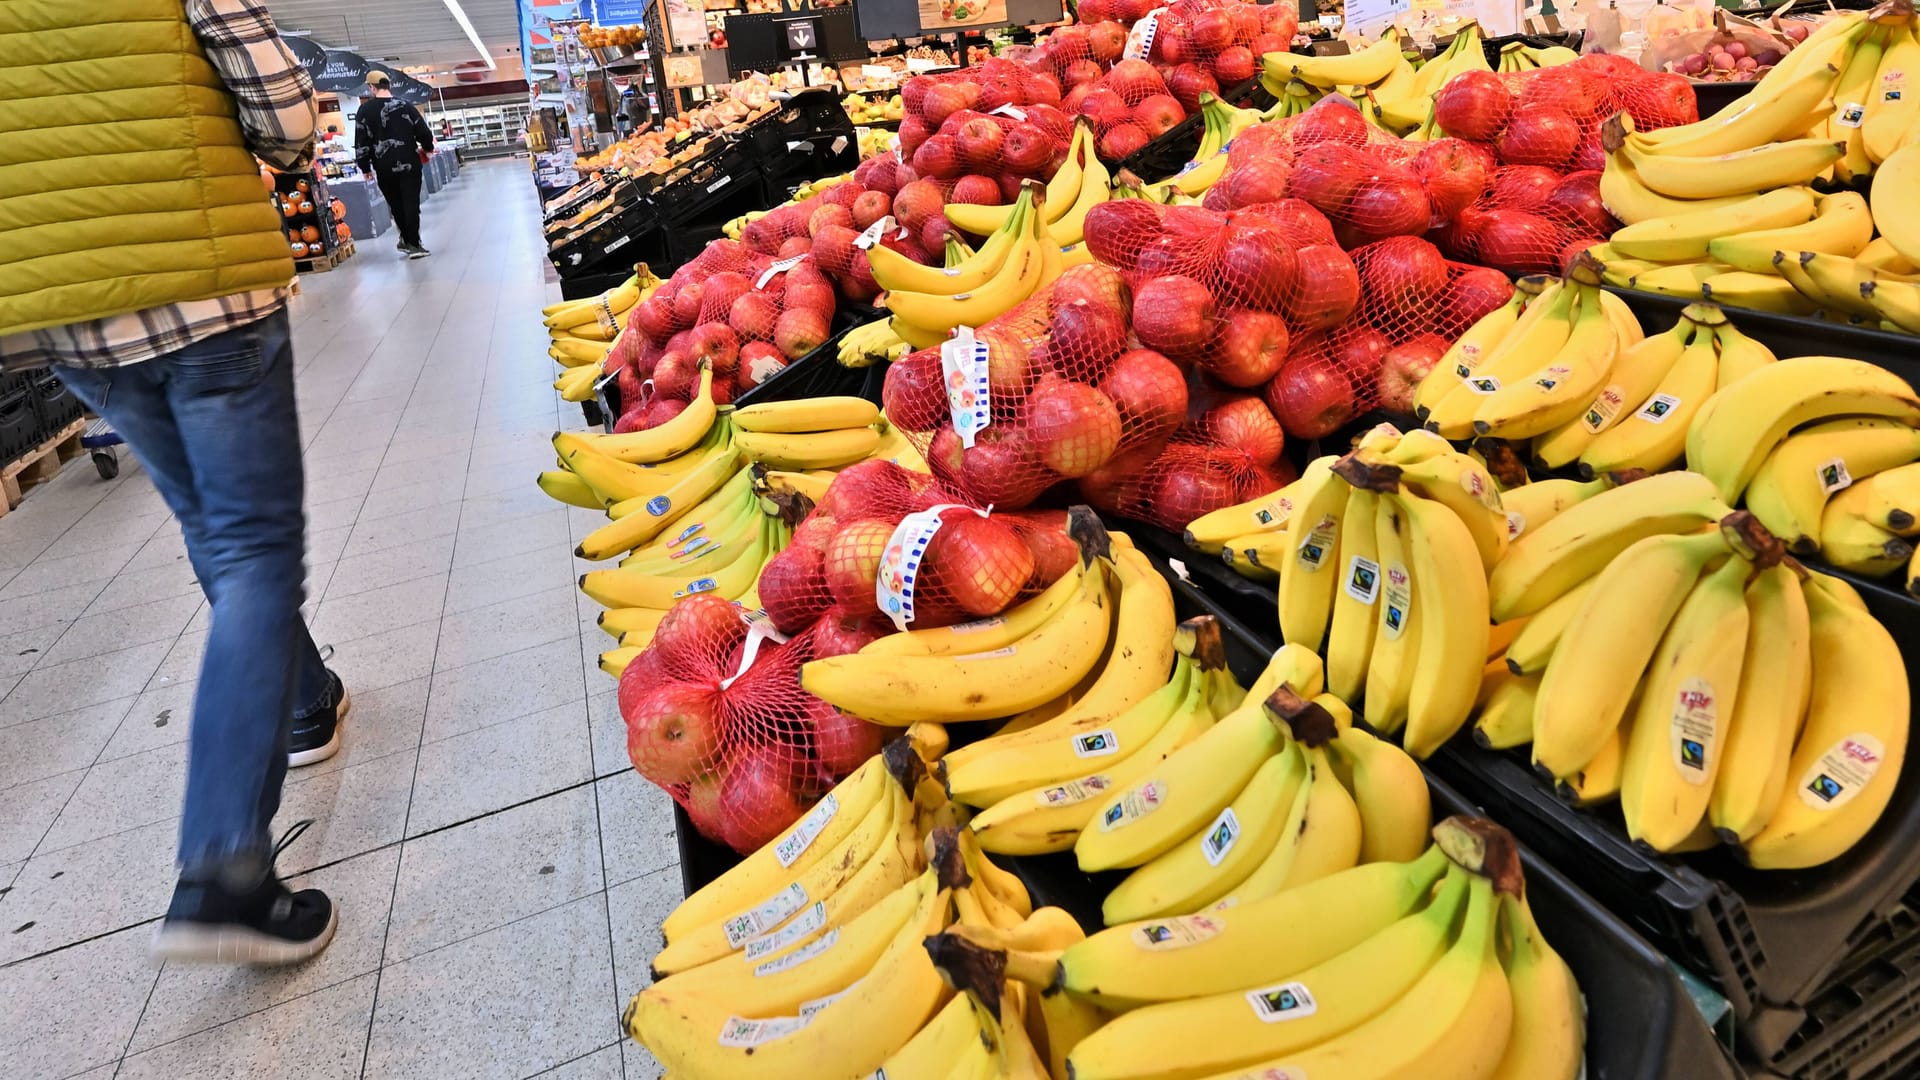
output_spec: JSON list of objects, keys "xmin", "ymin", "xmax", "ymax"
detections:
[{"xmin": 152, "ymin": 821, "xmax": 340, "ymax": 967}]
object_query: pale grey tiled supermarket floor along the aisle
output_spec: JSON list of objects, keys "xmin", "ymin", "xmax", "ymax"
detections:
[{"xmin": 0, "ymin": 161, "xmax": 680, "ymax": 1080}]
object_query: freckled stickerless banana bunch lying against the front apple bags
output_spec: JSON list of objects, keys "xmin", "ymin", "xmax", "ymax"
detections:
[{"xmin": 801, "ymin": 507, "xmax": 1173, "ymax": 730}]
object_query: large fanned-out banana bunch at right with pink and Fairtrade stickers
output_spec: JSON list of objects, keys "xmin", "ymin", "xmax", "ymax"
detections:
[{"xmin": 1475, "ymin": 453, "xmax": 1908, "ymax": 869}]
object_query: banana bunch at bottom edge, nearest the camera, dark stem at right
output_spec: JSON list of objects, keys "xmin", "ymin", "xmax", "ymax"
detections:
[{"xmin": 1052, "ymin": 819, "xmax": 1586, "ymax": 1080}]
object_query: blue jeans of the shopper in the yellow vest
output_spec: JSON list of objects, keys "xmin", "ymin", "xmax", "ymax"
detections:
[{"xmin": 60, "ymin": 309, "xmax": 328, "ymax": 888}]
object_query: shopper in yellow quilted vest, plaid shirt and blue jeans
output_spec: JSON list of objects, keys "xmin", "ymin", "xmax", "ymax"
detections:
[{"xmin": 0, "ymin": 0, "xmax": 346, "ymax": 963}]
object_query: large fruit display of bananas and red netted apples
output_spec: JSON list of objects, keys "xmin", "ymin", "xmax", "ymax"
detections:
[{"xmin": 540, "ymin": 0, "xmax": 1920, "ymax": 1080}]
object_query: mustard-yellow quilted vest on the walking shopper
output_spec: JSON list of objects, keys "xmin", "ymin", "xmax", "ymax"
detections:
[{"xmin": 0, "ymin": 0, "xmax": 294, "ymax": 336}]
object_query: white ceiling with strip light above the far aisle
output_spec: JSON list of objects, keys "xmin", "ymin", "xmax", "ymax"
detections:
[{"xmin": 267, "ymin": 0, "xmax": 520, "ymax": 69}]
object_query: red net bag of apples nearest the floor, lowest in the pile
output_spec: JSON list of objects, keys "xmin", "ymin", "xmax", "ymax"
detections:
[{"xmin": 620, "ymin": 594, "xmax": 889, "ymax": 853}]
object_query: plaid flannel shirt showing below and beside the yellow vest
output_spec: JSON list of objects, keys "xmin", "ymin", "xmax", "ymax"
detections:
[{"xmin": 0, "ymin": 0, "xmax": 319, "ymax": 367}]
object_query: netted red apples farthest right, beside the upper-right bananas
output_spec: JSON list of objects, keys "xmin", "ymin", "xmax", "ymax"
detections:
[{"xmin": 1434, "ymin": 52, "xmax": 1699, "ymax": 171}]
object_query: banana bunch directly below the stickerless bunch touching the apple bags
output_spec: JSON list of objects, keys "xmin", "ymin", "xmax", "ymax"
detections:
[{"xmin": 947, "ymin": 614, "xmax": 1246, "ymax": 855}]
